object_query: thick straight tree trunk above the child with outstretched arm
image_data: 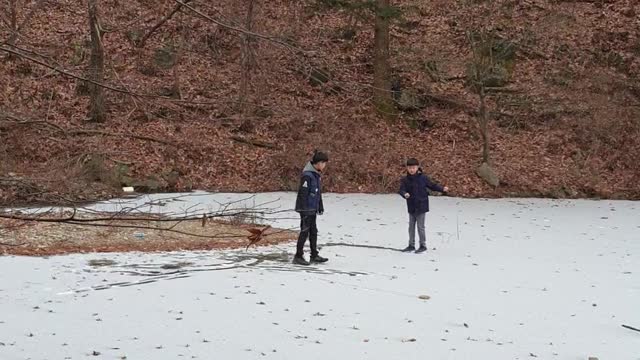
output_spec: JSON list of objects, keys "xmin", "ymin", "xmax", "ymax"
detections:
[{"xmin": 373, "ymin": 0, "xmax": 395, "ymax": 117}]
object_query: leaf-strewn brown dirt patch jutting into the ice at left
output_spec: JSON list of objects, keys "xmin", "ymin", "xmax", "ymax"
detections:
[{"xmin": 0, "ymin": 219, "xmax": 296, "ymax": 256}]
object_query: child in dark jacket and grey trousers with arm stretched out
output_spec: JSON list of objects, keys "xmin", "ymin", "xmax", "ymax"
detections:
[{"xmin": 399, "ymin": 158, "xmax": 449, "ymax": 254}]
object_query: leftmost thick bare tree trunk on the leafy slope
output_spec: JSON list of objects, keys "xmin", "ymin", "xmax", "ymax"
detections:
[{"xmin": 89, "ymin": 0, "xmax": 106, "ymax": 123}]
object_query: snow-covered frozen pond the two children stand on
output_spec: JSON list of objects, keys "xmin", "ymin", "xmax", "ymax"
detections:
[{"xmin": 0, "ymin": 193, "xmax": 640, "ymax": 360}]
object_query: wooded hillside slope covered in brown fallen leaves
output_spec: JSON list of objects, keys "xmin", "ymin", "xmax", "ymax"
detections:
[{"xmin": 0, "ymin": 0, "xmax": 640, "ymax": 204}]
